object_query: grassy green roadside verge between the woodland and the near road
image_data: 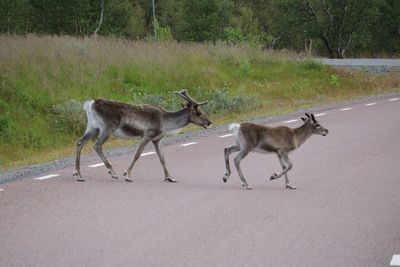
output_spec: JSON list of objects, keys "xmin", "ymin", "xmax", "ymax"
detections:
[{"xmin": 0, "ymin": 36, "xmax": 400, "ymax": 169}]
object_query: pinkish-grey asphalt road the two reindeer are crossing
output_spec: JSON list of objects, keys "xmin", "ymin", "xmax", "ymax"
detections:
[{"xmin": 0, "ymin": 95, "xmax": 400, "ymax": 266}]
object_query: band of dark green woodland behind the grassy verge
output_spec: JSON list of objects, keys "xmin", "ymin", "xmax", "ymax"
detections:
[{"xmin": 0, "ymin": 0, "xmax": 400, "ymax": 58}]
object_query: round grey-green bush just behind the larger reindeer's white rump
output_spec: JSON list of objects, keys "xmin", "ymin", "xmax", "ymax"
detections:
[{"xmin": 50, "ymin": 99, "xmax": 86, "ymax": 136}]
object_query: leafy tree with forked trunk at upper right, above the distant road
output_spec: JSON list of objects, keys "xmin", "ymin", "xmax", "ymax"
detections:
[{"xmin": 275, "ymin": 0, "xmax": 379, "ymax": 58}]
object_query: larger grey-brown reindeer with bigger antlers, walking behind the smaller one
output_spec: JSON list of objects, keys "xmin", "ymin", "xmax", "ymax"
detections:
[{"xmin": 73, "ymin": 89, "xmax": 211, "ymax": 182}]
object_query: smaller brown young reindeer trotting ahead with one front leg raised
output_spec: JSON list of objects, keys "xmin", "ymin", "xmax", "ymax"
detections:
[{"xmin": 223, "ymin": 113, "xmax": 328, "ymax": 190}]
